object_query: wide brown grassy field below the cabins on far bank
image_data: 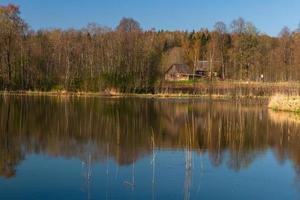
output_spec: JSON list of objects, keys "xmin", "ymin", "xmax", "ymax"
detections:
[{"xmin": 161, "ymin": 80, "xmax": 300, "ymax": 97}]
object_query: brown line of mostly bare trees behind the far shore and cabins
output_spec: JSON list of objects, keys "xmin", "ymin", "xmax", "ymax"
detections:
[{"xmin": 0, "ymin": 4, "xmax": 300, "ymax": 92}]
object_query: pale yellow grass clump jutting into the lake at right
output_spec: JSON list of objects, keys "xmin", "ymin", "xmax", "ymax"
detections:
[{"xmin": 269, "ymin": 94, "xmax": 300, "ymax": 112}]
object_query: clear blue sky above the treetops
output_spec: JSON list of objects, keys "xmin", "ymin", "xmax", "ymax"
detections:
[{"xmin": 0, "ymin": 0, "xmax": 300, "ymax": 36}]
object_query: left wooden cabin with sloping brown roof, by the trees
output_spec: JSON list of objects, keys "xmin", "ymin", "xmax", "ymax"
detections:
[{"xmin": 165, "ymin": 64, "xmax": 193, "ymax": 81}]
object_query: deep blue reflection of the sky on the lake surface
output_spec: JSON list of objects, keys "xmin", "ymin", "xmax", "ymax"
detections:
[{"xmin": 0, "ymin": 150, "xmax": 299, "ymax": 200}]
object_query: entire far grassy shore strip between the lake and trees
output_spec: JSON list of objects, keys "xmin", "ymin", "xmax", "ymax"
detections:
[{"xmin": 0, "ymin": 81, "xmax": 300, "ymax": 99}]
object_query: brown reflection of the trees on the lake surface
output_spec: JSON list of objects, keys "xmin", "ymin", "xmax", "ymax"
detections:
[{"xmin": 0, "ymin": 97, "xmax": 300, "ymax": 180}]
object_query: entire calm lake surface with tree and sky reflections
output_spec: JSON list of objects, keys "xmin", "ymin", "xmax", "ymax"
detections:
[{"xmin": 0, "ymin": 97, "xmax": 300, "ymax": 200}]
